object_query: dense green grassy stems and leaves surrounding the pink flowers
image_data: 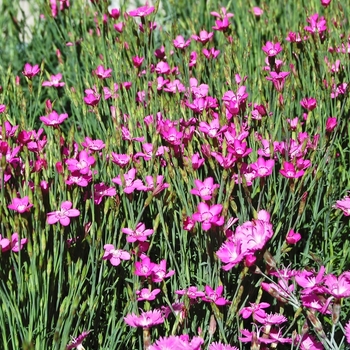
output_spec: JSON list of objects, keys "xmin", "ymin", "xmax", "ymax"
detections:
[{"xmin": 0, "ymin": 0, "xmax": 350, "ymax": 349}]
